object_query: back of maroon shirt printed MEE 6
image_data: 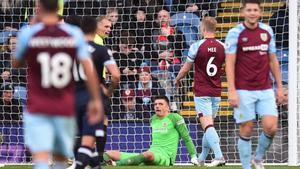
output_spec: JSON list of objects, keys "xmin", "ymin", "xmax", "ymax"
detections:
[{"xmin": 194, "ymin": 38, "xmax": 225, "ymax": 97}]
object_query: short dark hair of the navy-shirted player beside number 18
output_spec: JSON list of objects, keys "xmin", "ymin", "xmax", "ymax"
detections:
[{"xmin": 80, "ymin": 16, "xmax": 97, "ymax": 34}]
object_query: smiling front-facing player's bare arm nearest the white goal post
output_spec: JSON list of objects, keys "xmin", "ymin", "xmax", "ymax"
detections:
[{"xmin": 270, "ymin": 53, "xmax": 284, "ymax": 104}]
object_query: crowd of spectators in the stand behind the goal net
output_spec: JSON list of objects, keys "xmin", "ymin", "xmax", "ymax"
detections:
[{"xmin": 0, "ymin": 0, "xmax": 288, "ymax": 121}]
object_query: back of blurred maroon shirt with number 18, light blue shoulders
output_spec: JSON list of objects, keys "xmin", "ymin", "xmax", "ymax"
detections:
[{"xmin": 20, "ymin": 23, "xmax": 83, "ymax": 116}]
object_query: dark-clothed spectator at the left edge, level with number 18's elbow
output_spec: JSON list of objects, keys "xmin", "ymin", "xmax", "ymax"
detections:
[{"xmin": 0, "ymin": 83, "xmax": 23, "ymax": 123}]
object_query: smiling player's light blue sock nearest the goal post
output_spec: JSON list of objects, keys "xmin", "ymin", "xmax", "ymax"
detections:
[{"xmin": 255, "ymin": 132, "xmax": 273, "ymax": 161}]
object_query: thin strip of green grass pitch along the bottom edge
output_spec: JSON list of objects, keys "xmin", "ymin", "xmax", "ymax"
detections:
[{"xmin": 1, "ymin": 165, "xmax": 300, "ymax": 169}]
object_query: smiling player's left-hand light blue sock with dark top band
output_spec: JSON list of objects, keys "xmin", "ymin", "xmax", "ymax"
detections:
[{"xmin": 238, "ymin": 136, "xmax": 252, "ymax": 169}]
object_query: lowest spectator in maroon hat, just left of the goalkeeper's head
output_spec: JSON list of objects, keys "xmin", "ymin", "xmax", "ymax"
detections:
[{"xmin": 112, "ymin": 89, "xmax": 146, "ymax": 120}]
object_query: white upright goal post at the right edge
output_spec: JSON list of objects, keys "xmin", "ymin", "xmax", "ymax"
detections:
[{"xmin": 288, "ymin": 0, "xmax": 300, "ymax": 166}]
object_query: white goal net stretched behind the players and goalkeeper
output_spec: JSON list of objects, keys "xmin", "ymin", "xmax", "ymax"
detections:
[{"xmin": 0, "ymin": 0, "xmax": 300, "ymax": 163}]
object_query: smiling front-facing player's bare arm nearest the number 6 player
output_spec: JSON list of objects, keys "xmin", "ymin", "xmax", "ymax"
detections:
[{"xmin": 225, "ymin": 54, "xmax": 239, "ymax": 107}]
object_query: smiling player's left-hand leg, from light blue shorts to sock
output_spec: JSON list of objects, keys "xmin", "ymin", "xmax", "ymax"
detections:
[{"xmin": 234, "ymin": 90, "xmax": 258, "ymax": 169}]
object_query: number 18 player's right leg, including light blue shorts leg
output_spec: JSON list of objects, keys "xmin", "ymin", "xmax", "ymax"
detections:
[{"xmin": 53, "ymin": 116, "xmax": 76, "ymax": 169}]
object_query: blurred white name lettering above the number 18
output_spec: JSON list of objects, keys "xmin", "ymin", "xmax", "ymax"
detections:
[{"xmin": 28, "ymin": 37, "xmax": 76, "ymax": 48}]
